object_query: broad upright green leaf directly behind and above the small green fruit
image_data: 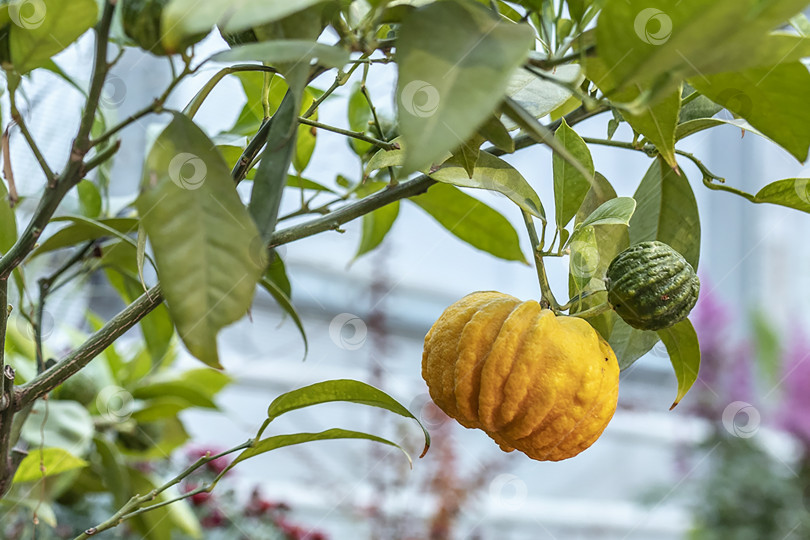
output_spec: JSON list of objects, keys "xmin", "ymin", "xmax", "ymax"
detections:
[{"xmin": 630, "ymin": 159, "xmax": 700, "ymax": 270}]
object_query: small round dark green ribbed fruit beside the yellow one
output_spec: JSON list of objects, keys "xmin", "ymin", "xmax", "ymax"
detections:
[{"xmin": 605, "ymin": 241, "xmax": 700, "ymax": 330}]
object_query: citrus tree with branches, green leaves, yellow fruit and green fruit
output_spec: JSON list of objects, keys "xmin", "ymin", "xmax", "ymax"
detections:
[{"xmin": 0, "ymin": 0, "xmax": 810, "ymax": 538}]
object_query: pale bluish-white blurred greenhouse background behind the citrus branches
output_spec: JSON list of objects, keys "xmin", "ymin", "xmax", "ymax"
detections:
[{"xmin": 3, "ymin": 17, "xmax": 810, "ymax": 540}]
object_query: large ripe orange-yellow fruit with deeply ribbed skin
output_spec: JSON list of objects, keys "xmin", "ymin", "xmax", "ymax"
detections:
[{"xmin": 422, "ymin": 292, "xmax": 619, "ymax": 461}]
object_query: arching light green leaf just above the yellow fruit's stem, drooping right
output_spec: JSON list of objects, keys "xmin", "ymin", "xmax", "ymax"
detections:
[{"xmin": 429, "ymin": 151, "xmax": 546, "ymax": 220}]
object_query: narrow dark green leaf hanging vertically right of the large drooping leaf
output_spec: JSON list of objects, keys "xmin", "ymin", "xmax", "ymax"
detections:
[{"xmin": 248, "ymin": 91, "xmax": 298, "ymax": 240}]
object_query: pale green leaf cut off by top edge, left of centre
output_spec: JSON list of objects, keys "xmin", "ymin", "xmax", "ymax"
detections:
[{"xmin": 161, "ymin": 0, "xmax": 332, "ymax": 51}]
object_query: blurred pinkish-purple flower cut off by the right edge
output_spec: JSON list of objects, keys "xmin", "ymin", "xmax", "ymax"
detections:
[{"xmin": 778, "ymin": 332, "xmax": 810, "ymax": 449}]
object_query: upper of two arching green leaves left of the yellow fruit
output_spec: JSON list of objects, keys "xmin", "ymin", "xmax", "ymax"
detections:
[{"xmin": 259, "ymin": 379, "xmax": 430, "ymax": 457}]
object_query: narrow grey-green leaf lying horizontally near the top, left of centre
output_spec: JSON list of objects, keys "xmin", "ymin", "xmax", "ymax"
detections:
[{"xmin": 211, "ymin": 39, "xmax": 349, "ymax": 68}]
